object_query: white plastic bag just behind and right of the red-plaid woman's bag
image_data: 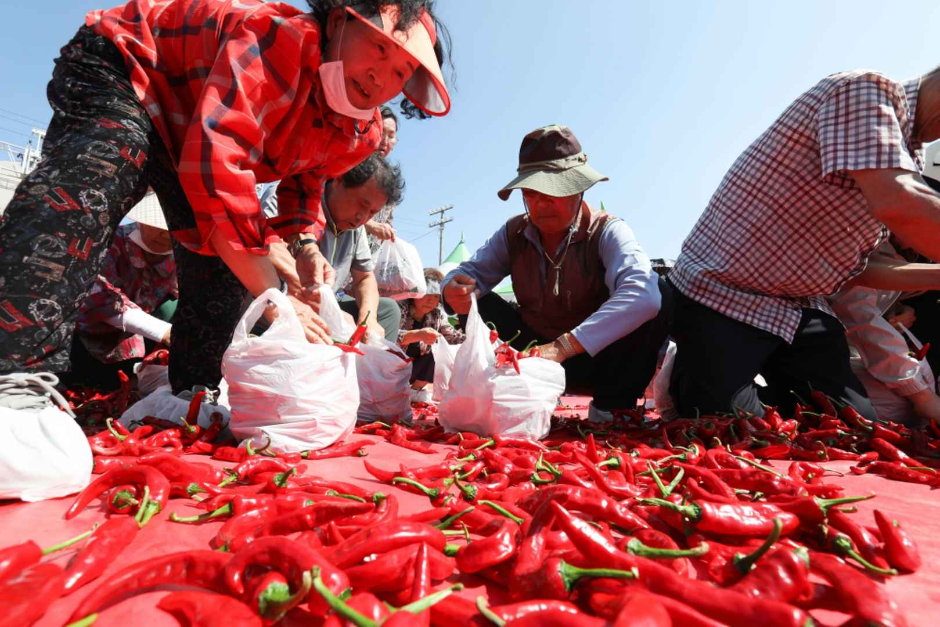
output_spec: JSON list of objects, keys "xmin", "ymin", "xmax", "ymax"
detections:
[{"xmin": 320, "ymin": 286, "xmax": 411, "ymax": 421}]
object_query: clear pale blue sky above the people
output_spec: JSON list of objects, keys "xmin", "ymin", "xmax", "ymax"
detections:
[{"xmin": 0, "ymin": 0, "xmax": 940, "ymax": 265}]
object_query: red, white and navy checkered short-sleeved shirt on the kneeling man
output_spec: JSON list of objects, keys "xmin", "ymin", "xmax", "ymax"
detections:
[{"xmin": 669, "ymin": 70, "xmax": 923, "ymax": 342}]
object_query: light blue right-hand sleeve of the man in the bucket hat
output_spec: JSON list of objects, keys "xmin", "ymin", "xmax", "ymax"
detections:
[{"xmin": 571, "ymin": 220, "xmax": 662, "ymax": 356}]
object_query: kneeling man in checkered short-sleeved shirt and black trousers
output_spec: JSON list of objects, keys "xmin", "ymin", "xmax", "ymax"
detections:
[{"xmin": 669, "ymin": 68, "xmax": 940, "ymax": 418}]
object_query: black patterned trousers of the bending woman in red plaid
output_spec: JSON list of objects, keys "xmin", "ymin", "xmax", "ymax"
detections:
[{"xmin": 0, "ymin": 27, "xmax": 245, "ymax": 392}]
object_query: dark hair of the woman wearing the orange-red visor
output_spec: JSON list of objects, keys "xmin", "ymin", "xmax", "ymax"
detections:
[{"xmin": 307, "ymin": 0, "xmax": 457, "ymax": 119}]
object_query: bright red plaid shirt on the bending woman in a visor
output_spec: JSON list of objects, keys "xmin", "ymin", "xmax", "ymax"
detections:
[{"xmin": 85, "ymin": 0, "xmax": 382, "ymax": 254}]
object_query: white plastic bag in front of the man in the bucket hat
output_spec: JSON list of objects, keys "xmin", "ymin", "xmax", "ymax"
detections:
[{"xmin": 438, "ymin": 297, "xmax": 565, "ymax": 439}]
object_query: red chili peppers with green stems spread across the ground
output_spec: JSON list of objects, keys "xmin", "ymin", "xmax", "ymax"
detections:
[{"xmin": 0, "ymin": 395, "xmax": 940, "ymax": 627}]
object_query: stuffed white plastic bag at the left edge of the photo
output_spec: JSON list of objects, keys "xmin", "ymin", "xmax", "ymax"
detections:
[{"xmin": 0, "ymin": 406, "xmax": 92, "ymax": 501}]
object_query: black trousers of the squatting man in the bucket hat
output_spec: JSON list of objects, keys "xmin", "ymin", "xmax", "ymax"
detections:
[{"xmin": 460, "ymin": 293, "xmax": 667, "ymax": 410}]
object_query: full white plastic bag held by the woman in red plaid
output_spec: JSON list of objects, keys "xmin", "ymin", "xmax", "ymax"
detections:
[{"xmin": 222, "ymin": 289, "xmax": 359, "ymax": 452}]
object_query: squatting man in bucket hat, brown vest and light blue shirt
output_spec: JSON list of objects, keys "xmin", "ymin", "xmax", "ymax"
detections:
[{"xmin": 443, "ymin": 125, "xmax": 666, "ymax": 422}]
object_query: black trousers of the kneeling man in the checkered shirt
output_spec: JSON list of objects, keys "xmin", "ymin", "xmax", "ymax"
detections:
[{"xmin": 667, "ymin": 284, "xmax": 875, "ymax": 419}]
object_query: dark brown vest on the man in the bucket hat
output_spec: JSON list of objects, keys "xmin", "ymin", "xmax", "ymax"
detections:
[{"xmin": 506, "ymin": 205, "xmax": 619, "ymax": 339}]
